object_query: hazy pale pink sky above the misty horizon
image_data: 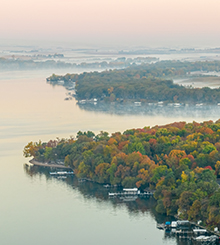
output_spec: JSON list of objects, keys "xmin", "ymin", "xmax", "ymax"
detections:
[{"xmin": 0, "ymin": 0, "xmax": 220, "ymax": 47}]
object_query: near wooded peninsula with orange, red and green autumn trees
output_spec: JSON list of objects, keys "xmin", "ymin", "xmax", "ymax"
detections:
[{"xmin": 24, "ymin": 120, "xmax": 220, "ymax": 229}]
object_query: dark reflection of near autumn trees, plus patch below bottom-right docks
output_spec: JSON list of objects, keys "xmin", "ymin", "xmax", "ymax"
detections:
[{"xmin": 23, "ymin": 164, "xmax": 208, "ymax": 245}]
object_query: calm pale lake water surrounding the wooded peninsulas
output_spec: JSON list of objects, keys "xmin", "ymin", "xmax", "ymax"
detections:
[{"xmin": 0, "ymin": 71, "xmax": 219, "ymax": 245}]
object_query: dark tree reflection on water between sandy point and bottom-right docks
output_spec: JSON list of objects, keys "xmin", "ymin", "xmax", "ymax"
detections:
[{"xmin": 24, "ymin": 164, "xmax": 170, "ymax": 223}]
